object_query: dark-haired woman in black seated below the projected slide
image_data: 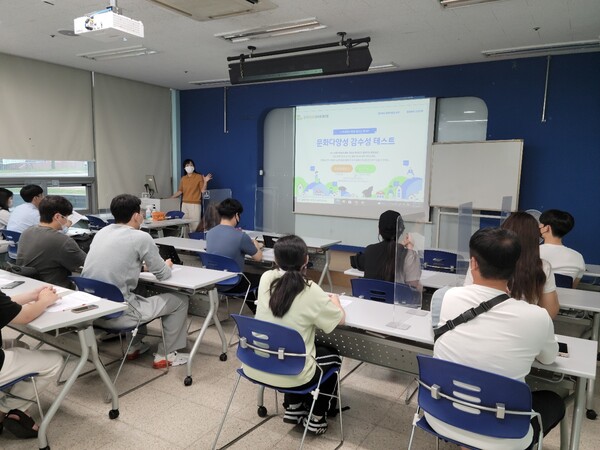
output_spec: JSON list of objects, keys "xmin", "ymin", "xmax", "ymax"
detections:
[{"xmin": 356, "ymin": 210, "xmax": 421, "ymax": 287}]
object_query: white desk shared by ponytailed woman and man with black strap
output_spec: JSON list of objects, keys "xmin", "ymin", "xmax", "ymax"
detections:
[{"xmin": 318, "ymin": 296, "xmax": 598, "ymax": 450}]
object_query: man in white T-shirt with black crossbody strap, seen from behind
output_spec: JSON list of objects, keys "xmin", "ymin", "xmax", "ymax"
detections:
[{"xmin": 427, "ymin": 228, "xmax": 565, "ymax": 450}]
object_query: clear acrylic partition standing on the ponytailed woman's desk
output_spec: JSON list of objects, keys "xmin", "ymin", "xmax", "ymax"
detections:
[{"xmin": 387, "ymin": 214, "xmax": 427, "ymax": 330}]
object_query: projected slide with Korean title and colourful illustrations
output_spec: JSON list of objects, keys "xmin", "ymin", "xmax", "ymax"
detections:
[{"xmin": 294, "ymin": 98, "xmax": 435, "ymax": 221}]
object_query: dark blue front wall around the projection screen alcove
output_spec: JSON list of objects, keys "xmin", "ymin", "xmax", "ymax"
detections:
[{"xmin": 181, "ymin": 53, "xmax": 600, "ymax": 263}]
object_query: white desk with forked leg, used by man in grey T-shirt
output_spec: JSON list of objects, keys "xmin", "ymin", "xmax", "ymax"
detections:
[{"xmin": 140, "ymin": 266, "xmax": 237, "ymax": 386}]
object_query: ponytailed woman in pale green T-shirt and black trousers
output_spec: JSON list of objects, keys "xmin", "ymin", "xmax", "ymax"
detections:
[{"xmin": 244, "ymin": 235, "xmax": 345, "ymax": 434}]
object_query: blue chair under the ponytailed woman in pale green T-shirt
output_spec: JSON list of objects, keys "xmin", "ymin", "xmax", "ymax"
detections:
[{"xmin": 212, "ymin": 314, "xmax": 344, "ymax": 450}]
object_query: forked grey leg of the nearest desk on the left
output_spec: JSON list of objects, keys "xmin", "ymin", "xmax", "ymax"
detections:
[{"xmin": 38, "ymin": 325, "xmax": 119, "ymax": 449}]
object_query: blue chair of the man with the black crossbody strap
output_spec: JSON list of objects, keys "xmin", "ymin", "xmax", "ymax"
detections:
[{"xmin": 408, "ymin": 355, "xmax": 542, "ymax": 450}]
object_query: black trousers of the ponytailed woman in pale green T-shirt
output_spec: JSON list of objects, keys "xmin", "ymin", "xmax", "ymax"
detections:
[{"xmin": 284, "ymin": 345, "xmax": 342, "ymax": 416}]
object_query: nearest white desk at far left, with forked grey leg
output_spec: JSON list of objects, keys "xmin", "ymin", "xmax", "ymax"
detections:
[{"xmin": 0, "ymin": 270, "xmax": 127, "ymax": 448}]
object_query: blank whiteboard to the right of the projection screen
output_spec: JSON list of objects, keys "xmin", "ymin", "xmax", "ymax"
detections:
[{"xmin": 430, "ymin": 140, "xmax": 523, "ymax": 211}]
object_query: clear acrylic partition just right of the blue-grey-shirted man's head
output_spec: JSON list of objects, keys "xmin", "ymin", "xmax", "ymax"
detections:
[{"xmin": 254, "ymin": 188, "xmax": 295, "ymax": 234}]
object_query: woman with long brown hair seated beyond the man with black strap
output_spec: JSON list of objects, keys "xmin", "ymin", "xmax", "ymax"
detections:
[{"xmin": 458, "ymin": 211, "xmax": 560, "ymax": 319}]
